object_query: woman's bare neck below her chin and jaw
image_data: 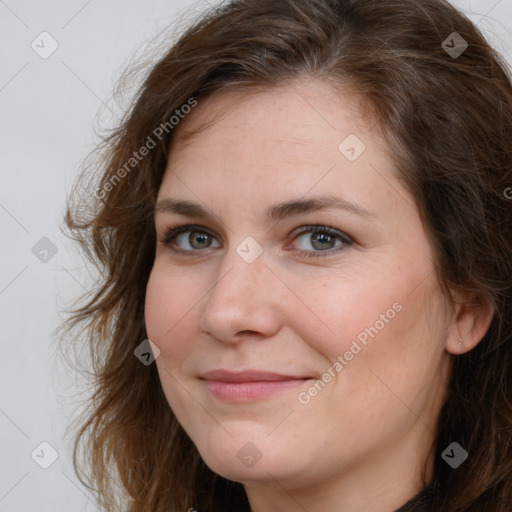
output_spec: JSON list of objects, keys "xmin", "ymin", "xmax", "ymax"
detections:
[{"xmin": 245, "ymin": 422, "xmax": 433, "ymax": 512}]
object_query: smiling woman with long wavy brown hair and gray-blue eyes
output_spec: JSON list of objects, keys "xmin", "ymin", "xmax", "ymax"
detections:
[{"xmin": 58, "ymin": 0, "xmax": 512, "ymax": 512}]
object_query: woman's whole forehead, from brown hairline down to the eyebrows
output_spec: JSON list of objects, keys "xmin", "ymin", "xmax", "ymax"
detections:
[{"xmin": 159, "ymin": 81, "xmax": 412, "ymax": 226}]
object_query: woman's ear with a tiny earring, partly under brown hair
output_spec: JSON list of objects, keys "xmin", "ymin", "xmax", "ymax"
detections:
[{"xmin": 446, "ymin": 292, "xmax": 494, "ymax": 355}]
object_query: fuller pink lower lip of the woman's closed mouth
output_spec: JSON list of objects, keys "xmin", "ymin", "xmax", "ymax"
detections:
[{"xmin": 205, "ymin": 379, "xmax": 309, "ymax": 402}]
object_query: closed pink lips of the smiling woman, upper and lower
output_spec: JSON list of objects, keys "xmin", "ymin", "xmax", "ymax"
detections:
[{"xmin": 201, "ymin": 370, "xmax": 312, "ymax": 403}]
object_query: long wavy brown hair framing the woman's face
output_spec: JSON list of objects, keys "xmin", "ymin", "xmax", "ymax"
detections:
[{"xmin": 59, "ymin": 0, "xmax": 512, "ymax": 512}]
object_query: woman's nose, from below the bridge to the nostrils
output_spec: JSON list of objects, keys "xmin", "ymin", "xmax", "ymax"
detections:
[{"xmin": 200, "ymin": 245, "xmax": 284, "ymax": 343}]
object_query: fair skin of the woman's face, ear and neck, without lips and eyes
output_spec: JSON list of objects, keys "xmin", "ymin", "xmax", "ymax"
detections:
[{"xmin": 146, "ymin": 79, "xmax": 492, "ymax": 512}]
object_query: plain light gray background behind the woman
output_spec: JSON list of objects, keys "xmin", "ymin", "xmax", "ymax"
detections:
[{"xmin": 0, "ymin": 0, "xmax": 512, "ymax": 512}]
